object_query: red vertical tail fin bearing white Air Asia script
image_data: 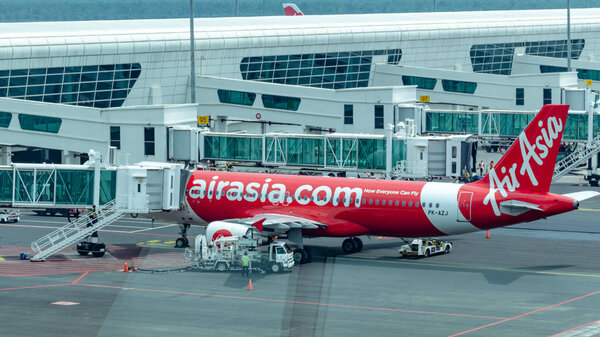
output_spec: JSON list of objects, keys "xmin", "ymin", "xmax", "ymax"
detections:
[{"xmin": 473, "ymin": 104, "xmax": 569, "ymax": 195}]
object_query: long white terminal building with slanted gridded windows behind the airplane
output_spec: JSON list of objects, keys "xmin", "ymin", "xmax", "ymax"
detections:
[{"xmin": 0, "ymin": 9, "xmax": 600, "ymax": 168}]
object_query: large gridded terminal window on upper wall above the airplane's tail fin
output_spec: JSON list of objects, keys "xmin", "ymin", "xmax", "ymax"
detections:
[{"xmin": 470, "ymin": 39, "xmax": 585, "ymax": 75}]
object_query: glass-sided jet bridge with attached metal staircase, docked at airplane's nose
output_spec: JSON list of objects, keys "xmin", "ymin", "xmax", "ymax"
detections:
[{"xmin": 0, "ymin": 151, "xmax": 189, "ymax": 261}]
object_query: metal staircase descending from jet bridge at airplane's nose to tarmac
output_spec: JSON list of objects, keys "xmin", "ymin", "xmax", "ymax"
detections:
[{"xmin": 31, "ymin": 200, "xmax": 123, "ymax": 261}]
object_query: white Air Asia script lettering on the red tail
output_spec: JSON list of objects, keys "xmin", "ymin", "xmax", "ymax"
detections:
[{"xmin": 483, "ymin": 117, "xmax": 563, "ymax": 216}]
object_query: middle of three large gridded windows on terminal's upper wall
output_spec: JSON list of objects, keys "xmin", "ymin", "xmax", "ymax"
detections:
[{"xmin": 240, "ymin": 49, "xmax": 402, "ymax": 89}]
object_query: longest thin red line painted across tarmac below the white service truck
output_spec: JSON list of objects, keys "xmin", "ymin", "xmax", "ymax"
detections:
[{"xmin": 76, "ymin": 283, "xmax": 502, "ymax": 319}]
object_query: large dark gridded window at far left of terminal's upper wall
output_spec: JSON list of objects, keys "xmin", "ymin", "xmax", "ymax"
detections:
[{"xmin": 0, "ymin": 63, "xmax": 141, "ymax": 108}]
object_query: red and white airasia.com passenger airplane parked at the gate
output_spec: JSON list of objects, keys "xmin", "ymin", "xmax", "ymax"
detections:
[{"xmin": 156, "ymin": 105, "xmax": 600, "ymax": 263}]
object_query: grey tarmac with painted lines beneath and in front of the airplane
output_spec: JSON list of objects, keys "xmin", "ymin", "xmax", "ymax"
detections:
[{"xmin": 0, "ymin": 184, "xmax": 600, "ymax": 337}]
